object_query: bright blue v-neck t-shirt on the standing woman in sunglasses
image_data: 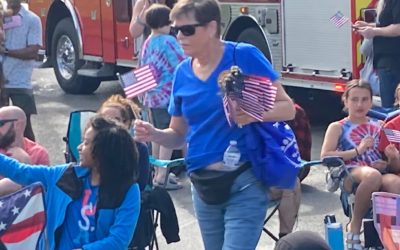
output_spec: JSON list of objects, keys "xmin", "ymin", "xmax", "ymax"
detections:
[{"xmin": 168, "ymin": 41, "xmax": 279, "ymax": 172}]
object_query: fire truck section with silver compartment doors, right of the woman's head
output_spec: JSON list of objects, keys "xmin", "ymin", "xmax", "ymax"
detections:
[{"xmin": 219, "ymin": 0, "xmax": 380, "ymax": 116}]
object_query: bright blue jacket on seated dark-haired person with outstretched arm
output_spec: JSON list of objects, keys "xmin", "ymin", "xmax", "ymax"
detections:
[{"xmin": 0, "ymin": 154, "xmax": 140, "ymax": 250}]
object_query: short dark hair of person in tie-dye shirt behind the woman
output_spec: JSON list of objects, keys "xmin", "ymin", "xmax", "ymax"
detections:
[{"xmin": 145, "ymin": 3, "xmax": 171, "ymax": 29}]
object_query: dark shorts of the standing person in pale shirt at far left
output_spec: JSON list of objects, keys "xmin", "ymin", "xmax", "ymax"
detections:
[{"xmin": 4, "ymin": 88, "xmax": 37, "ymax": 115}]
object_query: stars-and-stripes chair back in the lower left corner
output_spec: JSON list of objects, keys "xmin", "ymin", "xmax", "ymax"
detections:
[{"xmin": 0, "ymin": 183, "xmax": 46, "ymax": 250}]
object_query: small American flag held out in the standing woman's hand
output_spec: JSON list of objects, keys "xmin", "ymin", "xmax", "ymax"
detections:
[{"xmin": 119, "ymin": 64, "xmax": 157, "ymax": 98}]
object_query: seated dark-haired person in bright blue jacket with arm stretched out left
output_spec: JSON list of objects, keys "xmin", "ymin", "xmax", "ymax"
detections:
[{"xmin": 0, "ymin": 116, "xmax": 140, "ymax": 250}]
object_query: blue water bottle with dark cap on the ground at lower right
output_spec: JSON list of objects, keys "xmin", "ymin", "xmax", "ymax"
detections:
[{"xmin": 324, "ymin": 215, "xmax": 344, "ymax": 250}]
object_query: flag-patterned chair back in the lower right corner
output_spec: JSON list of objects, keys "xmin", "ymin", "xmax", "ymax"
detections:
[{"xmin": 372, "ymin": 192, "xmax": 400, "ymax": 250}]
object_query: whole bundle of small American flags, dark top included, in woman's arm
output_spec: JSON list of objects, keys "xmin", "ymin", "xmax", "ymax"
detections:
[{"xmin": 219, "ymin": 66, "xmax": 277, "ymax": 126}]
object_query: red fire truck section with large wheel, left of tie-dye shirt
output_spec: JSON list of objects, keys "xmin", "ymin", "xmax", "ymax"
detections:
[{"xmin": 29, "ymin": 0, "xmax": 140, "ymax": 94}]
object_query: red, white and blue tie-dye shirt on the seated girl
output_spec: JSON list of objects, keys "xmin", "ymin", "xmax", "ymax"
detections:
[{"xmin": 338, "ymin": 118, "xmax": 382, "ymax": 167}]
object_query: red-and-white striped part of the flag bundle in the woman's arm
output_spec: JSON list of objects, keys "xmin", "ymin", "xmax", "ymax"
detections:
[{"xmin": 222, "ymin": 69, "xmax": 277, "ymax": 125}]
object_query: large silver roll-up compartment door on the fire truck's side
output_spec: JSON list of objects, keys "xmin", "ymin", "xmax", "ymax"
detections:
[{"xmin": 283, "ymin": 0, "xmax": 352, "ymax": 76}]
